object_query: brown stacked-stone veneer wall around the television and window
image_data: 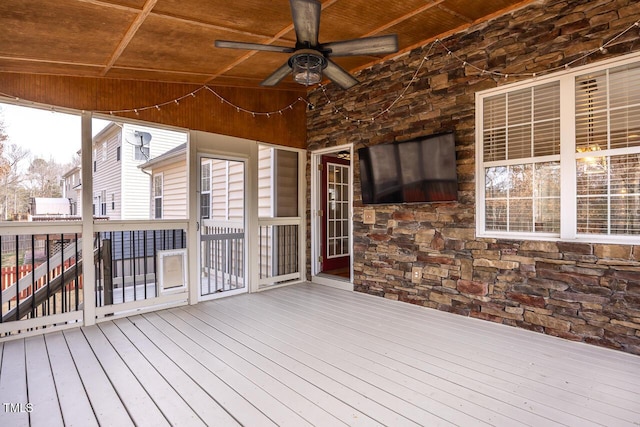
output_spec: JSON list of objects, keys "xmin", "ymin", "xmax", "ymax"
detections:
[{"xmin": 307, "ymin": 0, "xmax": 640, "ymax": 354}]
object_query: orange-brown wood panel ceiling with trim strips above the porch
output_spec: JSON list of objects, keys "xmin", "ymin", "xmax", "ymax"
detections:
[{"xmin": 0, "ymin": 0, "xmax": 532, "ymax": 90}]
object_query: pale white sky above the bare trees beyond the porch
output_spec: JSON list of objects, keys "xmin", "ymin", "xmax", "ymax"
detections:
[{"xmin": 0, "ymin": 103, "xmax": 109, "ymax": 164}]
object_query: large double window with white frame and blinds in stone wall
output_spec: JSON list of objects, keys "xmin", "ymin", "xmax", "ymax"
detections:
[{"xmin": 476, "ymin": 52, "xmax": 640, "ymax": 242}]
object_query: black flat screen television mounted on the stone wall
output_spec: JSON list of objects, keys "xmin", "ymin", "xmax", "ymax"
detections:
[{"xmin": 358, "ymin": 132, "xmax": 458, "ymax": 204}]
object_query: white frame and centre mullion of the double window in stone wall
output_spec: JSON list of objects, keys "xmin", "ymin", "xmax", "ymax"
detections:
[{"xmin": 475, "ymin": 53, "xmax": 640, "ymax": 244}]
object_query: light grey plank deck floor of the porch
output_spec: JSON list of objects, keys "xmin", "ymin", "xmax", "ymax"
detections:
[{"xmin": 0, "ymin": 284, "xmax": 640, "ymax": 427}]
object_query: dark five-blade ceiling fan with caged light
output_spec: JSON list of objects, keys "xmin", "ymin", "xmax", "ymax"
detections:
[{"xmin": 215, "ymin": 0, "xmax": 398, "ymax": 89}]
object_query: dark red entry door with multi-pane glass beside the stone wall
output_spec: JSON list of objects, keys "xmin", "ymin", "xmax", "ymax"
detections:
[{"xmin": 321, "ymin": 156, "xmax": 351, "ymax": 274}]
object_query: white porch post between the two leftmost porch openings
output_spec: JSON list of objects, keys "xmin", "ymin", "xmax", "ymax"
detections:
[{"xmin": 81, "ymin": 111, "xmax": 96, "ymax": 326}]
